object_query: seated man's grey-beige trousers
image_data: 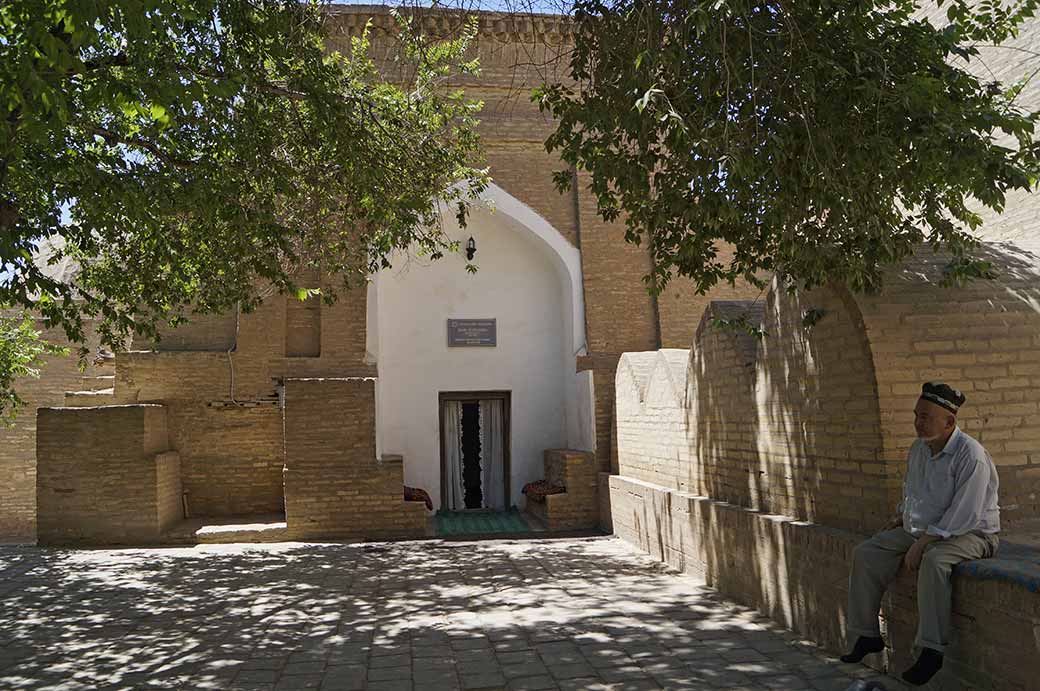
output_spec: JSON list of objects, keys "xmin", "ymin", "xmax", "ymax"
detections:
[{"xmin": 848, "ymin": 528, "xmax": 999, "ymax": 652}]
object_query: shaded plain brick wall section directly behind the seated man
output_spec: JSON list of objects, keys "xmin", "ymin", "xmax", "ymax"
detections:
[{"xmin": 857, "ymin": 248, "xmax": 1040, "ymax": 526}]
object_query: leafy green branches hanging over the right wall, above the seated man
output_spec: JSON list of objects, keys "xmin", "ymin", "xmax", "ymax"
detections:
[{"xmin": 536, "ymin": 0, "xmax": 1040, "ymax": 291}]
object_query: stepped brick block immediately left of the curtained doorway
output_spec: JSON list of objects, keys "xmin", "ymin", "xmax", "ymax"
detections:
[{"xmin": 285, "ymin": 379, "xmax": 425, "ymax": 539}]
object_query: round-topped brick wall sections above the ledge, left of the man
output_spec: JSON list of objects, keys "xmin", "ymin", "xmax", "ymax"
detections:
[{"xmin": 617, "ymin": 286, "xmax": 898, "ymax": 530}]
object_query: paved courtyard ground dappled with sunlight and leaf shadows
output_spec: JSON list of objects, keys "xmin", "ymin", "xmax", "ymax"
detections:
[{"xmin": 0, "ymin": 538, "xmax": 900, "ymax": 691}]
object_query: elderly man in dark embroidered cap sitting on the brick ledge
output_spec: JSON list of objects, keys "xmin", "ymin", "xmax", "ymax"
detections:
[{"xmin": 841, "ymin": 382, "xmax": 1000, "ymax": 686}]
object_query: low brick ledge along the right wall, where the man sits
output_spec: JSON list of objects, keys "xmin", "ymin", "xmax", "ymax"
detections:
[{"xmin": 609, "ymin": 476, "xmax": 1040, "ymax": 691}]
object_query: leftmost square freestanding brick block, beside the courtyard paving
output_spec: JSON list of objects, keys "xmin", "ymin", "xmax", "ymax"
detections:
[{"xmin": 36, "ymin": 405, "xmax": 183, "ymax": 544}]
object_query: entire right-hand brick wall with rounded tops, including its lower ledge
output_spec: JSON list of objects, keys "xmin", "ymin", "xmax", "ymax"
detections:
[{"xmin": 608, "ymin": 240, "xmax": 1040, "ymax": 689}]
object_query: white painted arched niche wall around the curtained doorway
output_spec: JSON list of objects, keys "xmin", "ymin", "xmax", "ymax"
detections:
[{"xmin": 376, "ymin": 202, "xmax": 593, "ymax": 506}]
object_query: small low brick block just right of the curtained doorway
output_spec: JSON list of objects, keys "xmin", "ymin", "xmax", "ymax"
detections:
[{"xmin": 527, "ymin": 449, "xmax": 600, "ymax": 530}]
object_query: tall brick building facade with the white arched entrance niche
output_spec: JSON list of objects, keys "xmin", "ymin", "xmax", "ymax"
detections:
[{"xmin": 0, "ymin": 6, "xmax": 761, "ymax": 541}]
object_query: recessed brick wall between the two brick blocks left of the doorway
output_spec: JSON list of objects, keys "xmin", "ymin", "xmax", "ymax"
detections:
[{"xmin": 115, "ymin": 277, "xmax": 369, "ymax": 516}]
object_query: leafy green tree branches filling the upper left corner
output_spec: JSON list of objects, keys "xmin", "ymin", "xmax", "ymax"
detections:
[{"xmin": 0, "ymin": 0, "xmax": 487, "ymax": 351}]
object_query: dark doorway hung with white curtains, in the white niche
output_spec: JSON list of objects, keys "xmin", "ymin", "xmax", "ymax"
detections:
[{"xmin": 439, "ymin": 391, "xmax": 510, "ymax": 511}]
